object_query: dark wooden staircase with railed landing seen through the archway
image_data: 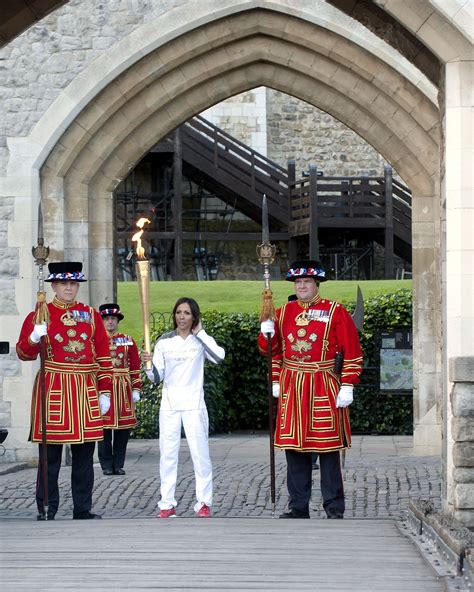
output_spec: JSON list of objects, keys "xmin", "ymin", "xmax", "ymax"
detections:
[{"xmin": 147, "ymin": 116, "xmax": 411, "ymax": 277}]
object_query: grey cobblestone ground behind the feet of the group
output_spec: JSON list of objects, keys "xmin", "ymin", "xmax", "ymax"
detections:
[{"xmin": 0, "ymin": 436, "xmax": 441, "ymax": 519}]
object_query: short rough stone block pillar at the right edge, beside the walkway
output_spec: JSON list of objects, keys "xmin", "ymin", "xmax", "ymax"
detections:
[{"xmin": 449, "ymin": 357, "xmax": 474, "ymax": 528}]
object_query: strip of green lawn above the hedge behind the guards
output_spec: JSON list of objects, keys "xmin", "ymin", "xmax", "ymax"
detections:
[{"xmin": 118, "ymin": 280, "xmax": 412, "ymax": 340}]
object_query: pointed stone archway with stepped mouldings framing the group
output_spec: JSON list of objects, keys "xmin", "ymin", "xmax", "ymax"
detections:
[{"xmin": 34, "ymin": 10, "xmax": 441, "ymax": 462}]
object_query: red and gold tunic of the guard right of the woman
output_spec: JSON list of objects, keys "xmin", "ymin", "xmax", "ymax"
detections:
[{"xmin": 258, "ymin": 294, "xmax": 362, "ymax": 452}]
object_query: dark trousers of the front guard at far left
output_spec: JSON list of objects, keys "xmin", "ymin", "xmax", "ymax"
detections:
[{"xmin": 36, "ymin": 442, "xmax": 95, "ymax": 514}]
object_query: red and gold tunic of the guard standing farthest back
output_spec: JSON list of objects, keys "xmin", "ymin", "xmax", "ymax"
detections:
[{"xmin": 104, "ymin": 333, "xmax": 142, "ymax": 430}]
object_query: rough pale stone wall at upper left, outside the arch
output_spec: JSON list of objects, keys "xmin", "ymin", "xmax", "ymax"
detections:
[{"xmin": 0, "ymin": 0, "xmax": 183, "ymax": 173}]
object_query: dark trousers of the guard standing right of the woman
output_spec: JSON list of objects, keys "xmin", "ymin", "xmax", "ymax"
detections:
[{"xmin": 285, "ymin": 450, "xmax": 345, "ymax": 515}]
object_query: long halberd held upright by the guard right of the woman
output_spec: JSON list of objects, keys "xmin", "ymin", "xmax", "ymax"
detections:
[{"xmin": 257, "ymin": 194, "xmax": 276, "ymax": 516}]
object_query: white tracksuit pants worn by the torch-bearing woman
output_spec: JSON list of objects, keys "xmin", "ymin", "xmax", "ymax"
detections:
[{"xmin": 158, "ymin": 407, "xmax": 212, "ymax": 512}]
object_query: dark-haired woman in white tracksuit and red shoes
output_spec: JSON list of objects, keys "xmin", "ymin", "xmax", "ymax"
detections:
[{"xmin": 142, "ymin": 298, "xmax": 225, "ymax": 518}]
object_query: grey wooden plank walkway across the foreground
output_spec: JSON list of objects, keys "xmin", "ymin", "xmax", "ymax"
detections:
[{"xmin": 0, "ymin": 517, "xmax": 445, "ymax": 592}]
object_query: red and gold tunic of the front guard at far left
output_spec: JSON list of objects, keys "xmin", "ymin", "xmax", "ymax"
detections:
[{"xmin": 16, "ymin": 297, "xmax": 112, "ymax": 444}]
